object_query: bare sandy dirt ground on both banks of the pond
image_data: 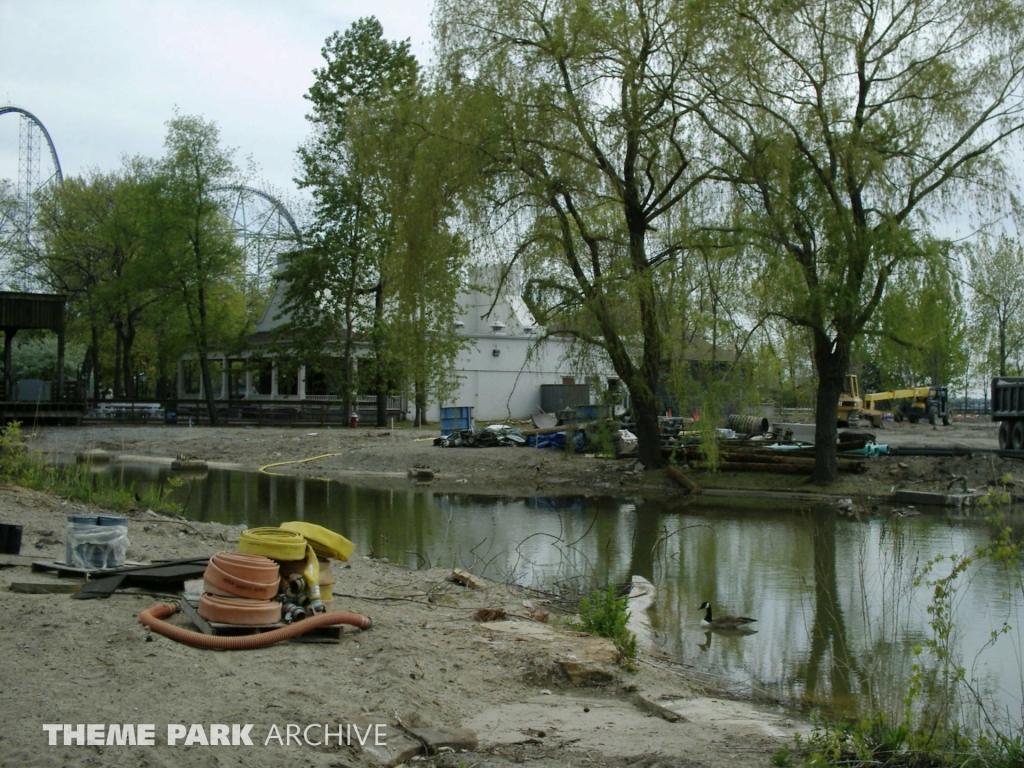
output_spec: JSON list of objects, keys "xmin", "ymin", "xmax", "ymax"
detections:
[{"xmin": 0, "ymin": 421, "xmax": 1011, "ymax": 768}]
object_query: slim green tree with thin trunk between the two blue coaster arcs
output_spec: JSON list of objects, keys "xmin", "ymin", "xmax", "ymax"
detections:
[{"xmin": 150, "ymin": 115, "xmax": 247, "ymax": 425}]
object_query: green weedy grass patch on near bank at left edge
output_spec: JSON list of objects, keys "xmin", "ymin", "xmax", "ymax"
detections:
[{"xmin": 0, "ymin": 422, "xmax": 182, "ymax": 514}]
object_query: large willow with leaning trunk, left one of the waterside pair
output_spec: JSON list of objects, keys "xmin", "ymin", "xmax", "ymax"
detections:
[{"xmin": 435, "ymin": 0, "xmax": 712, "ymax": 467}]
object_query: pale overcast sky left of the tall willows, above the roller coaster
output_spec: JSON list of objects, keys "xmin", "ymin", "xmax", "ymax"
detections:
[{"xmin": 0, "ymin": 0, "xmax": 433, "ymax": 210}]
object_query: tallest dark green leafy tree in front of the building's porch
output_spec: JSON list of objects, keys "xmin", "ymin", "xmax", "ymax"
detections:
[{"xmin": 280, "ymin": 17, "xmax": 419, "ymax": 423}]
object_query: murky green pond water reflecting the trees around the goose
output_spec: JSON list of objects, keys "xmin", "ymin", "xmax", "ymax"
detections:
[{"xmin": 90, "ymin": 467, "xmax": 1024, "ymax": 722}]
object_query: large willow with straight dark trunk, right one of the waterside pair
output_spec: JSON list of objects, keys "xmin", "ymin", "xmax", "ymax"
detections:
[{"xmin": 696, "ymin": 0, "xmax": 1024, "ymax": 480}]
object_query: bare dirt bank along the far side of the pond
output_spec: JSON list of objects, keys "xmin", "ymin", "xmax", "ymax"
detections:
[{"xmin": 14, "ymin": 411, "xmax": 1024, "ymax": 499}]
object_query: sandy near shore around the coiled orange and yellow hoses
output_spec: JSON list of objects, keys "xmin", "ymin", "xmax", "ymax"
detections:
[{"xmin": 0, "ymin": 487, "xmax": 802, "ymax": 768}]
